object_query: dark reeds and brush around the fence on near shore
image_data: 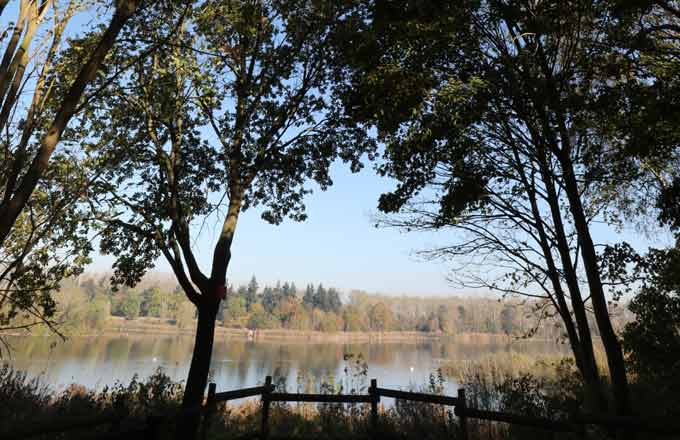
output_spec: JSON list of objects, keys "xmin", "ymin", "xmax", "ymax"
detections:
[{"xmin": 0, "ymin": 355, "xmax": 680, "ymax": 440}]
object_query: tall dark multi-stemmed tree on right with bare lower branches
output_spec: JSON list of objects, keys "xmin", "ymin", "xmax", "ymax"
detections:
[{"xmin": 337, "ymin": 1, "xmax": 644, "ymax": 415}]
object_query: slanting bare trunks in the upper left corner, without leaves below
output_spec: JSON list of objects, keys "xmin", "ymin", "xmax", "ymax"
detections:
[{"xmin": 0, "ymin": 0, "xmax": 141, "ymax": 246}]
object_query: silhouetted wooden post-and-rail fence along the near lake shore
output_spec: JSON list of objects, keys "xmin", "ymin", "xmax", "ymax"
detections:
[{"xmin": 8, "ymin": 376, "xmax": 680, "ymax": 440}]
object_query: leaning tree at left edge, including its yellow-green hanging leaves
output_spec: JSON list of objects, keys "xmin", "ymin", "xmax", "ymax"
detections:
[{"xmin": 0, "ymin": 0, "xmax": 141, "ymax": 332}]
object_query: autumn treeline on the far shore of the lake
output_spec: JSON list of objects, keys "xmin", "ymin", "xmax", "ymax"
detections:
[{"xmin": 34, "ymin": 275, "xmax": 625, "ymax": 338}]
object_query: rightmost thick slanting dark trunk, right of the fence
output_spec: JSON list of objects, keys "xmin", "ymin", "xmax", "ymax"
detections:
[{"xmin": 559, "ymin": 153, "xmax": 632, "ymax": 416}]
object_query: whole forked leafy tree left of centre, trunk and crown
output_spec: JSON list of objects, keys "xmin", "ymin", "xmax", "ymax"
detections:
[{"xmin": 78, "ymin": 0, "xmax": 374, "ymax": 437}]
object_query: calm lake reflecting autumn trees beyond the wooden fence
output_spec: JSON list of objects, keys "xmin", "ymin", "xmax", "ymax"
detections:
[{"xmin": 0, "ymin": 335, "xmax": 568, "ymax": 394}]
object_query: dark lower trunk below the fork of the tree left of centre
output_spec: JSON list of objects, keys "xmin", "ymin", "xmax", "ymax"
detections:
[{"xmin": 177, "ymin": 298, "xmax": 219, "ymax": 440}]
